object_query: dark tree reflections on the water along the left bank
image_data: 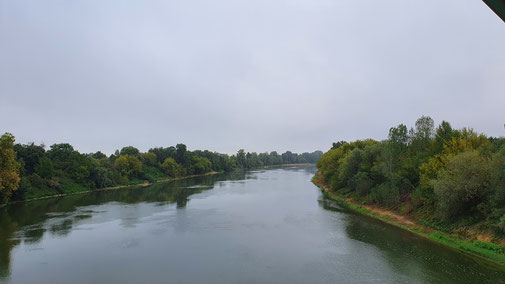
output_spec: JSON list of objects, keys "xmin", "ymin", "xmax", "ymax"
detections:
[{"xmin": 0, "ymin": 172, "xmax": 246, "ymax": 280}]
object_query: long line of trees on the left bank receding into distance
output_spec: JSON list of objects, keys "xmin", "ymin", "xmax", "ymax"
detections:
[{"xmin": 0, "ymin": 133, "xmax": 322, "ymax": 204}]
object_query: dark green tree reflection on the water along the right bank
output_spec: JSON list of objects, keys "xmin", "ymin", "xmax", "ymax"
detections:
[{"xmin": 319, "ymin": 197, "xmax": 505, "ymax": 283}]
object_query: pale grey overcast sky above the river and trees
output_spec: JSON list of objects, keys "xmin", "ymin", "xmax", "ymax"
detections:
[{"xmin": 0, "ymin": 0, "xmax": 505, "ymax": 153}]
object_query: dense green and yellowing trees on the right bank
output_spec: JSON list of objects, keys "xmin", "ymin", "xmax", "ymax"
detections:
[{"xmin": 316, "ymin": 116, "xmax": 505, "ymax": 240}]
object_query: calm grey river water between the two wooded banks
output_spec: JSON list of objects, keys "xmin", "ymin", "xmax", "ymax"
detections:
[{"xmin": 0, "ymin": 166, "xmax": 505, "ymax": 283}]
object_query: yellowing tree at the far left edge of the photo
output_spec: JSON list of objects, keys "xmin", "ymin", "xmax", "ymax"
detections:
[{"xmin": 0, "ymin": 133, "xmax": 20, "ymax": 203}]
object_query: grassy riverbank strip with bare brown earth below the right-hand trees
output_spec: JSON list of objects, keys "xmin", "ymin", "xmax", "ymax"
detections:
[{"xmin": 312, "ymin": 172, "xmax": 505, "ymax": 271}]
